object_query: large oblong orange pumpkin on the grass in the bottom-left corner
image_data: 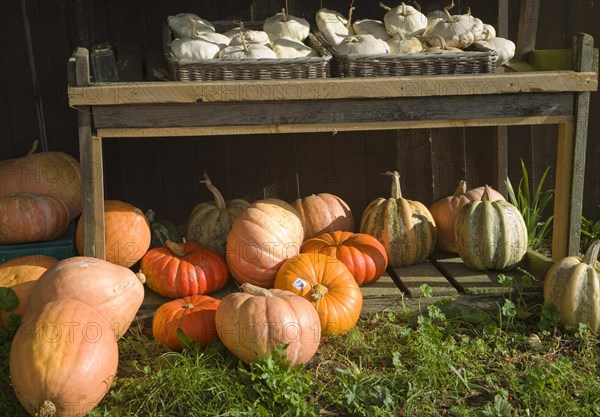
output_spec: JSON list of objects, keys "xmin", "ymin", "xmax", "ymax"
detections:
[{"xmin": 10, "ymin": 299, "xmax": 119, "ymax": 417}]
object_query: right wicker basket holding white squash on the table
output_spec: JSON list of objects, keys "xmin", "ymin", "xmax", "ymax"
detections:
[{"xmin": 315, "ymin": 32, "xmax": 498, "ymax": 77}]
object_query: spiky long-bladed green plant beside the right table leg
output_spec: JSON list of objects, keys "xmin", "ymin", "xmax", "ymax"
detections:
[{"xmin": 505, "ymin": 160, "xmax": 554, "ymax": 249}]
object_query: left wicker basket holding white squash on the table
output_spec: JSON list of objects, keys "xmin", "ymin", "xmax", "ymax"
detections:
[{"xmin": 163, "ymin": 22, "xmax": 332, "ymax": 81}]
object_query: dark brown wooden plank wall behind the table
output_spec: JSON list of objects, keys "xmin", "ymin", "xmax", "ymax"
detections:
[{"xmin": 0, "ymin": 0, "xmax": 600, "ymax": 228}]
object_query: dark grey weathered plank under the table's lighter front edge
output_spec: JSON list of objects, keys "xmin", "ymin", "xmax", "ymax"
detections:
[{"xmin": 93, "ymin": 93, "xmax": 573, "ymax": 129}]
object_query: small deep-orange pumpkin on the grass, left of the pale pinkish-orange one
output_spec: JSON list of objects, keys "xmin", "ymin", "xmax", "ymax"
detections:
[{"xmin": 152, "ymin": 295, "xmax": 221, "ymax": 351}]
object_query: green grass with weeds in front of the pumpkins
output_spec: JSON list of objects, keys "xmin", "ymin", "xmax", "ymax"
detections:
[{"xmin": 0, "ymin": 286, "xmax": 600, "ymax": 417}]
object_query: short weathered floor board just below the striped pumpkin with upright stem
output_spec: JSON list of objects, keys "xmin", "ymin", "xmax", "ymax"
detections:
[{"xmin": 390, "ymin": 261, "xmax": 458, "ymax": 298}]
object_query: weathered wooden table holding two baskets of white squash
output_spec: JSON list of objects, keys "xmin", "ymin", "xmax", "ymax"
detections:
[{"xmin": 68, "ymin": 34, "xmax": 598, "ymax": 260}]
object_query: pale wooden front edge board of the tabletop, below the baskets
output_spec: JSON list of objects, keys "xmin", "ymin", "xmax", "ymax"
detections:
[{"xmin": 68, "ymin": 71, "xmax": 598, "ymax": 106}]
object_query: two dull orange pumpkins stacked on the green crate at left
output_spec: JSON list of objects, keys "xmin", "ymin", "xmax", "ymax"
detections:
[{"xmin": 0, "ymin": 141, "xmax": 81, "ymax": 244}]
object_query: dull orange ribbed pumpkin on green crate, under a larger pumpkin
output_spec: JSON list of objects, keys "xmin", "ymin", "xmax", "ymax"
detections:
[{"xmin": 0, "ymin": 193, "xmax": 69, "ymax": 244}]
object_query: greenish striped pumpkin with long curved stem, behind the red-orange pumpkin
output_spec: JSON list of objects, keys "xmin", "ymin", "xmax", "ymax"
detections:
[{"xmin": 186, "ymin": 171, "xmax": 250, "ymax": 256}]
